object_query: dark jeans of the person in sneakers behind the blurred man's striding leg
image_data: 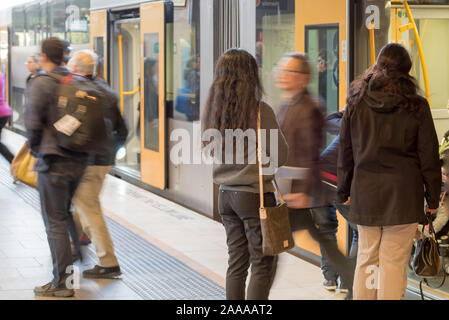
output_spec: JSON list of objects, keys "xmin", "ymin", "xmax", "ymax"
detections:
[{"xmin": 312, "ymin": 206, "xmax": 338, "ymax": 281}]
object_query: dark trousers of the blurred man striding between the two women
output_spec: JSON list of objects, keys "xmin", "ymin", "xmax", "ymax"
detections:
[{"xmin": 289, "ymin": 208, "xmax": 355, "ymax": 289}]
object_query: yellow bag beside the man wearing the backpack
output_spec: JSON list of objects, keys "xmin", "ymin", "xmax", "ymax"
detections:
[{"xmin": 11, "ymin": 142, "xmax": 37, "ymax": 188}]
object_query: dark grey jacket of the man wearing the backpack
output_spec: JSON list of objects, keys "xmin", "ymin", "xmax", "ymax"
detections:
[{"xmin": 25, "ymin": 66, "xmax": 87, "ymax": 171}]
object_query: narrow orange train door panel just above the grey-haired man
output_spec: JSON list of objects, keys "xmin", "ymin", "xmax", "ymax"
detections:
[{"xmin": 90, "ymin": 10, "xmax": 108, "ymax": 80}]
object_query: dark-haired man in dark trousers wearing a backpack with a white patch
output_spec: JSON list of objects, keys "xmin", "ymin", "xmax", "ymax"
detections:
[{"xmin": 25, "ymin": 37, "xmax": 104, "ymax": 297}]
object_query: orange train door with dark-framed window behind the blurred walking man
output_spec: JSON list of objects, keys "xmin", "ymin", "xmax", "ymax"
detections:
[{"xmin": 295, "ymin": 0, "xmax": 349, "ymax": 255}]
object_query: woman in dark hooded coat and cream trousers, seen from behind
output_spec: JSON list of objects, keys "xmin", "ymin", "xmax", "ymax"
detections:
[{"xmin": 338, "ymin": 44, "xmax": 441, "ymax": 300}]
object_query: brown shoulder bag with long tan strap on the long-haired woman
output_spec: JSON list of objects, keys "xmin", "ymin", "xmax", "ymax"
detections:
[{"xmin": 257, "ymin": 104, "xmax": 295, "ymax": 256}]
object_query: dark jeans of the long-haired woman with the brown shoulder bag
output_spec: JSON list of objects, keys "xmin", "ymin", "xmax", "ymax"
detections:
[{"xmin": 218, "ymin": 190, "xmax": 277, "ymax": 300}]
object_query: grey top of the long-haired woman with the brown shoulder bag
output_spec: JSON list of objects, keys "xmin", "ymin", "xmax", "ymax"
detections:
[{"xmin": 213, "ymin": 102, "xmax": 288, "ymax": 193}]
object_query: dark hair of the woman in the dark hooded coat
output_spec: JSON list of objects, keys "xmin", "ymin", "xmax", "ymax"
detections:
[{"xmin": 346, "ymin": 43, "xmax": 422, "ymax": 112}]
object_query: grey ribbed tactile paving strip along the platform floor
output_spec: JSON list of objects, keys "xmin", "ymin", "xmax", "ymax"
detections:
[{"xmin": 0, "ymin": 159, "xmax": 225, "ymax": 300}]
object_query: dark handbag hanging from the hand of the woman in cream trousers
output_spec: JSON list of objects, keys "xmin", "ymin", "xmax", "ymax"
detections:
[{"xmin": 412, "ymin": 212, "xmax": 446, "ymax": 300}]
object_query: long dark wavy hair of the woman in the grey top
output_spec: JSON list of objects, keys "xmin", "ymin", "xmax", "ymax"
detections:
[{"xmin": 203, "ymin": 48, "xmax": 263, "ymax": 135}]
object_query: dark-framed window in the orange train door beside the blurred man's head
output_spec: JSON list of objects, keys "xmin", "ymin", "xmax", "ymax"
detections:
[{"xmin": 305, "ymin": 25, "xmax": 340, "ymax": 114}]
